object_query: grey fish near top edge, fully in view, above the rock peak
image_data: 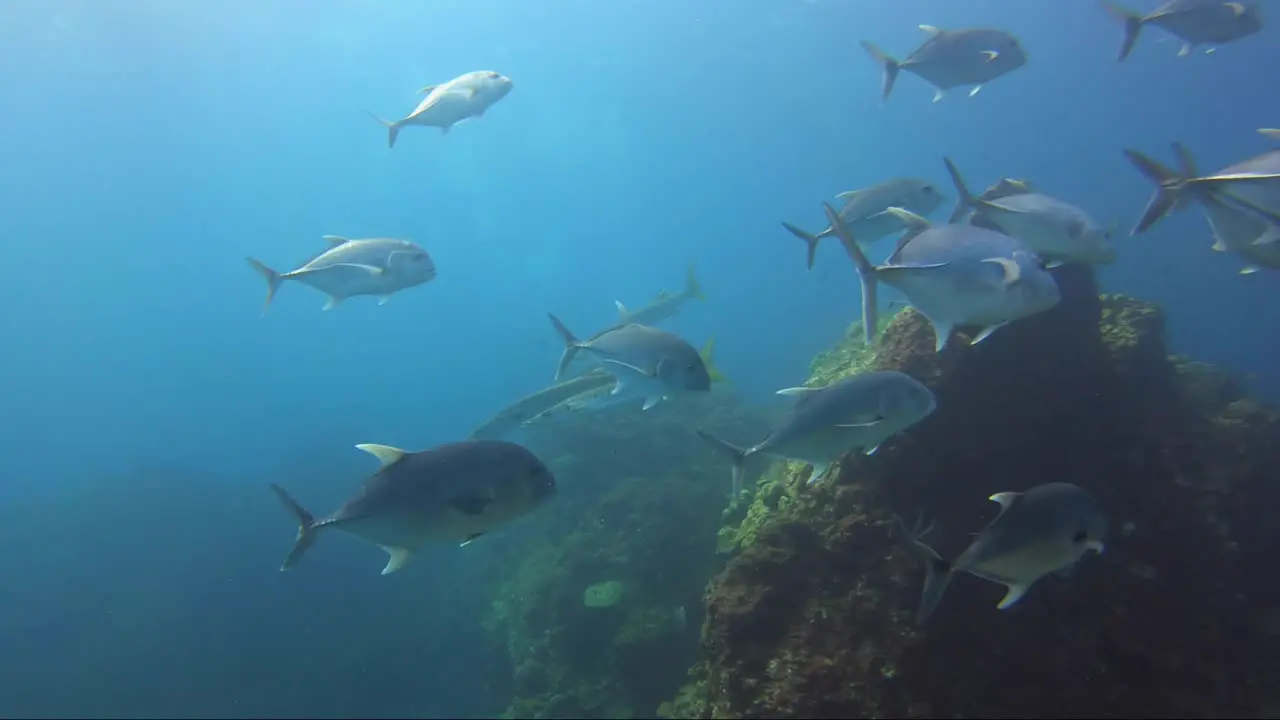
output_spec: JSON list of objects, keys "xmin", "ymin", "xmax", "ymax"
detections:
[{"xmin": 861, "ymin": 26, "xmax": 1027, "ymax": 102}]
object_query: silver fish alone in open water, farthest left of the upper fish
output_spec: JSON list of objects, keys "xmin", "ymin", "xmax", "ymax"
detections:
[{"xmin": 246, "ymin": 234, "xmax": 435, "ymax": 315}]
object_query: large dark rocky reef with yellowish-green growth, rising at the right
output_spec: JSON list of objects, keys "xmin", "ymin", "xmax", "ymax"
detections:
[{"xmin": 665, "ymin": 266, "xmax": 1280, "ymax": 717}]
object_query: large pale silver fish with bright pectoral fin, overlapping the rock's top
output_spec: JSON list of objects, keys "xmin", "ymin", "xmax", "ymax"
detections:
[{"xmin": 823, "ymin": 198, "xmax": 1061, "ymax": 351}]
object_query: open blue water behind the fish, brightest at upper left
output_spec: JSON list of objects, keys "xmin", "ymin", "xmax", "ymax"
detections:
[{"xmin": 0, "ymin": 0, "xmax": 1280, "ymax": 716}]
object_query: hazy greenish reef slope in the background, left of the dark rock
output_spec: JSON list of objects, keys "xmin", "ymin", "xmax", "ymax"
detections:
[{"xmin": 485, "ymin": 391, "xmax": 768, "ymax": 717}]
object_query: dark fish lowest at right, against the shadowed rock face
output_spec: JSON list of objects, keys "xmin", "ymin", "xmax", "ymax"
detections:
[{"xmin": 899, "ymin": 483, "xmax": 1107, "ymax": 623}]
